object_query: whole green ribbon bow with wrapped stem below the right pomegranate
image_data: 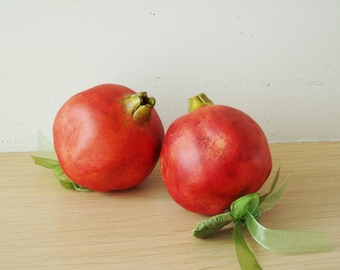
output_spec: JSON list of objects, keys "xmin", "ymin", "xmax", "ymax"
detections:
[{"xmin": 192, "ymin": 168, "xmax": 330, "ymax": 270}]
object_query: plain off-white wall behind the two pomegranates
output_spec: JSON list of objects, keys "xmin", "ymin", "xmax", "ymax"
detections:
[{"xmin": 0, "ymin": 0, "xmax": 340, "ymax": 152}]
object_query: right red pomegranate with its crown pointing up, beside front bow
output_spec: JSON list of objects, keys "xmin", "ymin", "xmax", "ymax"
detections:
[{"xmin": 160, "ymin": 94, "xmax": 272, "ymax": 215}]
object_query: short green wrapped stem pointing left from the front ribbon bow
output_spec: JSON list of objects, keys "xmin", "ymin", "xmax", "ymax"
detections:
[{"xmin": 191, "ymin": 212, "xmax": 233, "ymax": 238}]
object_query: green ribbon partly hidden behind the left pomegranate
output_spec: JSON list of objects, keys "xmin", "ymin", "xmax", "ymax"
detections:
[{"xmin": 32, "ymin": 132, "xmax": 90, "ymax": 191}]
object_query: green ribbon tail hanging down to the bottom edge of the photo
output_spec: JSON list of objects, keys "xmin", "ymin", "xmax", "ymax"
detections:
[{"xmin": 233, "ymin": 222, "xmax": 262, "ymax": 270}]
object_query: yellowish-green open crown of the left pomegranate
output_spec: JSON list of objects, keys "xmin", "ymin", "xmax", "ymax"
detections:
[{"xmin": 123, "ymin": 92, "xmax": 156, "ymax": 124}]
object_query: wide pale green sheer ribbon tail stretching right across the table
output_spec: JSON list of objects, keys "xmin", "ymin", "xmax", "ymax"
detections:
[{"xmin": 245, "ymin": 212, "xmax": 330, "ymax": 253}]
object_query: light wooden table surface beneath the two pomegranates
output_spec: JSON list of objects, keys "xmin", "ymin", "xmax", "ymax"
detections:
[{"xmin": 0, "ymin": 142, "xmax": 340, "ymax": 270}]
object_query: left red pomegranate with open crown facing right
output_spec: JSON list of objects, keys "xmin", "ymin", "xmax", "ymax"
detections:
[{"xmin": 53, "ymin": 84, "xmax": 164, "ymax": 191}]
